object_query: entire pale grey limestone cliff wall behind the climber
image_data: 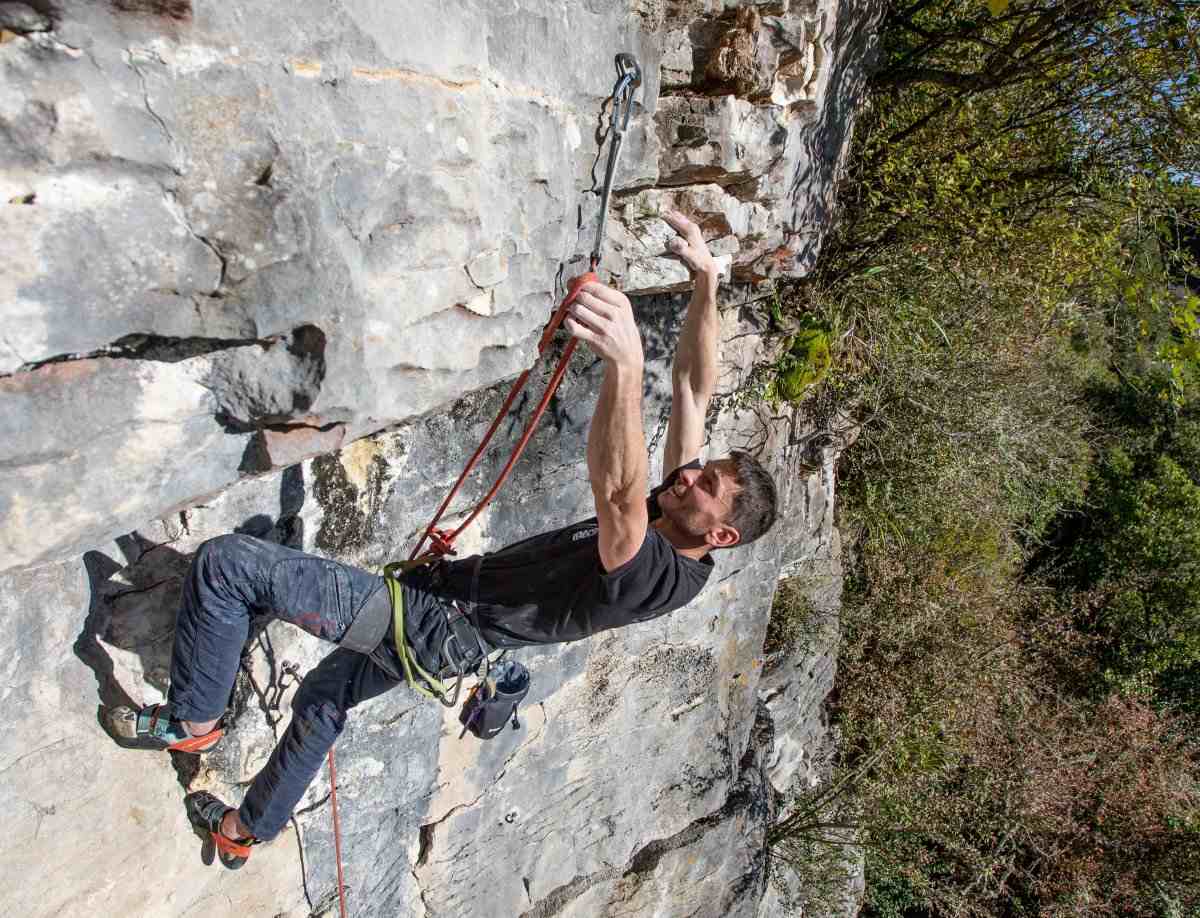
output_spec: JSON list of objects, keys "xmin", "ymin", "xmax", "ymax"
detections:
[{"xmin": 0, "ymin": 0, "xmax": 874, "ymax": 916}]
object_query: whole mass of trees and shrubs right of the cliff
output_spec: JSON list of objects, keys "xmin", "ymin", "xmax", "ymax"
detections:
[{"xmin": 770, "ymin": 0, "xmax": 1200, "ymax": 918}]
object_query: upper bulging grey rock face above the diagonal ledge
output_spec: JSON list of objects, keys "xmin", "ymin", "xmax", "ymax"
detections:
[{"xmin": 0, "ymin": 0, "xmax": 862, "ymax": 570}]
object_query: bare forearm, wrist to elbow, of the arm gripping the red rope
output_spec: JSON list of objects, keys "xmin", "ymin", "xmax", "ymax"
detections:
[{"xmin": 588, "ymin": 362, "xmax": 648, "ymax": 506}]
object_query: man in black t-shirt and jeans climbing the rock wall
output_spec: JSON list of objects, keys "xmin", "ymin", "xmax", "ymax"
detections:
[{"xmin": 109, "ymin": 211, "xmax": 776, "ymax": 868}]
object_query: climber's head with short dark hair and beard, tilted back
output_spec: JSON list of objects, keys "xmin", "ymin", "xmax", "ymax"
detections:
[{"xmin": 659, "ymin": 450, "xmax": 778, "ymax": 548}]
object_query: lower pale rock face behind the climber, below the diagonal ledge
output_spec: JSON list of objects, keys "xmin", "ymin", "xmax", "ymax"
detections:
[{"xmin": 0, "ymin": 298, "xmax": 833, "ymax": 918}]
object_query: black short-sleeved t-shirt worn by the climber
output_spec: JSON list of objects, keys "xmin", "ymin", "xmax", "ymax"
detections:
[{"xmin": 404, "ymin": 461, "xmax": 713, "ymax": 659}]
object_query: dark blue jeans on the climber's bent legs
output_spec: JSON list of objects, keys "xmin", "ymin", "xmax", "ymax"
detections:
[{"xmin": 167, "ymin": 535, "xmax": 401, "ymax": 841}]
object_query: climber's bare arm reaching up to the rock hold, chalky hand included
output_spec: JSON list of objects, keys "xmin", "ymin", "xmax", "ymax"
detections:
[{"xmin": 662, "ymin": 210, "xmax": 720, "ymax": 475}]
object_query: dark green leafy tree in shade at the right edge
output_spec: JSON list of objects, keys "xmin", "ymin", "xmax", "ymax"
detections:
[{"xmin": 1049, "ymin": 384, "xmax": 1200, "ymax": 715}]
